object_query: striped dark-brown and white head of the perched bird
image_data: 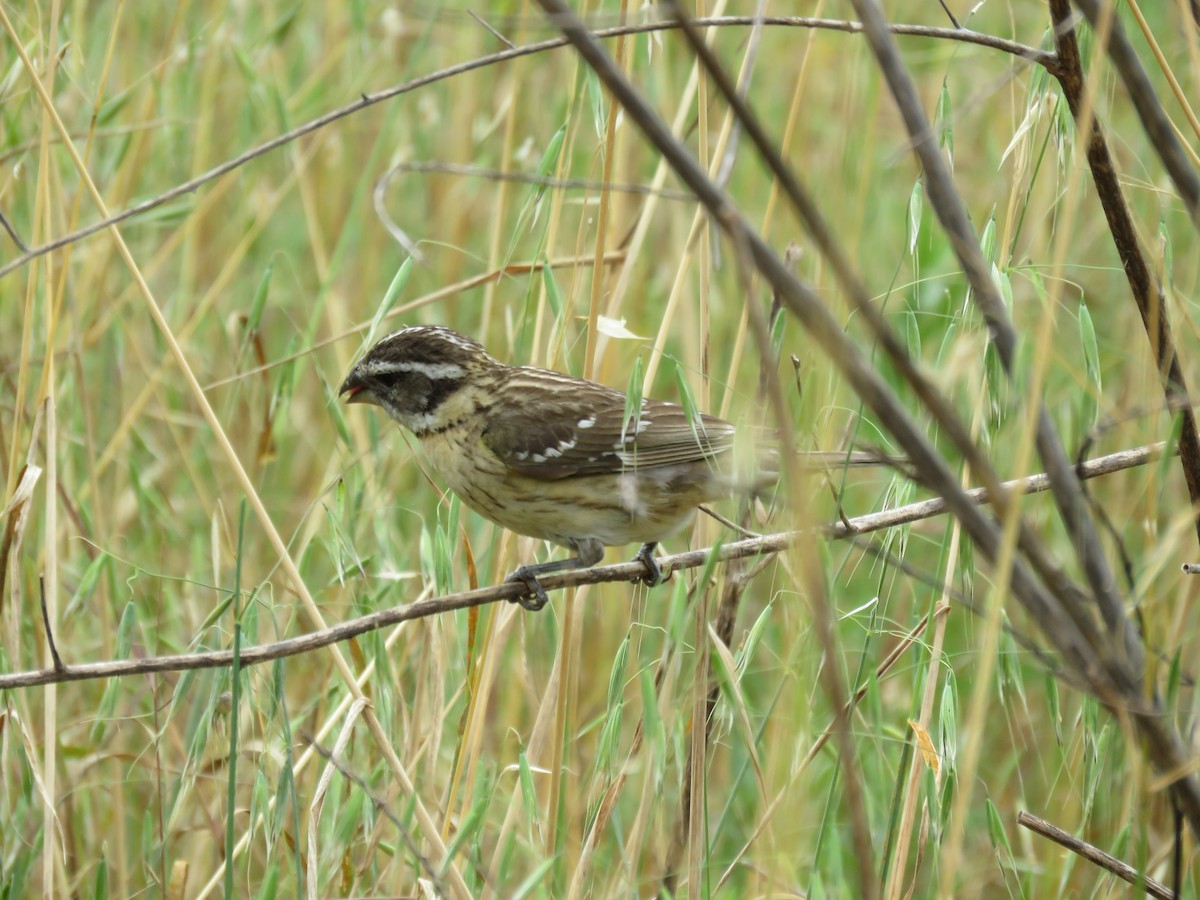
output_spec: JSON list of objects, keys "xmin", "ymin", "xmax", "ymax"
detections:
[{"xmin": 337, "ymin": 325, "xmax": 500, "ymax": 436}]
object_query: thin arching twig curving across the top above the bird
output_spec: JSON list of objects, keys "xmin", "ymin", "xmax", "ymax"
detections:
[{"xmin": 0, "ymin": 16, "xmax": 1055, "ymax": 278}]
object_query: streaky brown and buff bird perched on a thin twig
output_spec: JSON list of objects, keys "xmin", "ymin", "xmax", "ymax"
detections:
[{"xmin": 338, "ymin": 325, "xmax": 778, "ymax": 611}]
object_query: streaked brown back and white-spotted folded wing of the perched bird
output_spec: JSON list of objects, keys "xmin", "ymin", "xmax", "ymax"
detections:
[{"xmin": 482, "ymin": 367, "xmax": 733, "ymax": 480}]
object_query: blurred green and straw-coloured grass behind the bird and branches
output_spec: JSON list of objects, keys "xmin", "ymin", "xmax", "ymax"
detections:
[{"xmin": 0, "ymin": 0, "xmax": 1200, "ymax": 898}]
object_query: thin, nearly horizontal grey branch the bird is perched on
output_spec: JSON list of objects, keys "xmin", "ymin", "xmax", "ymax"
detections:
[{"xmin": 0, "ymin": 444, "xmax": 1166, "ymax": 691}]
